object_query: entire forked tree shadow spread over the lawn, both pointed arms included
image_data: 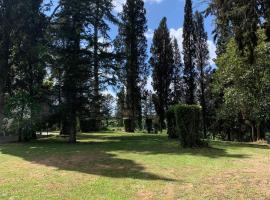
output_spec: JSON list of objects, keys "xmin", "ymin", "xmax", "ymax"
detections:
[{"xmin": 0, "ymin": 134, "xmax": 251, "ymax": 181}]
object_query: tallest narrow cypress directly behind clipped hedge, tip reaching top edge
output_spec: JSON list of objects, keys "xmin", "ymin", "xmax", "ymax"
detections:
[{"xmin": 183, "ymin": 0, "xmax": 196, "ymax": 104}]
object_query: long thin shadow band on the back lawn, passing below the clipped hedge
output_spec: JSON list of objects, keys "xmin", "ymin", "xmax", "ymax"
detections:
[{"xmin": 75, "ymin": 134, "xmax": 250, "ymax": 158}]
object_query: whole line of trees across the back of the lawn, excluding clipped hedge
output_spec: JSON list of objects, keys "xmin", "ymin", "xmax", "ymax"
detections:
[{"xmin": 0, "ymin": 0, "xmax": 270, "ymax": 143}]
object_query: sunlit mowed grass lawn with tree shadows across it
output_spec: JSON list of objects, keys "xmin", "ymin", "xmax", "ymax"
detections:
[{"xmin": 0, "ymin": 132, "xmax": 270, "ymax": 200}]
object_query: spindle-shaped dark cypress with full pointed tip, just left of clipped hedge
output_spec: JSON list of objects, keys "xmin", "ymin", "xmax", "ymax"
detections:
[{"xmin": 150, "ymin": 18, "xmax": 174, "ymax": 128}]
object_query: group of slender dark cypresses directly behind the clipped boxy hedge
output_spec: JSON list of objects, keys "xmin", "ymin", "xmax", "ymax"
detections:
[{"xmin": 150, "ymin": 0, "xmax": 211, "ymax": 136}]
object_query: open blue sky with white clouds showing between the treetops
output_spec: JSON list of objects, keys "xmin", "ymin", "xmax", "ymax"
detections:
[{"xmin": 111, "ymin": 0, "xmax": 216, "ymax": 65}]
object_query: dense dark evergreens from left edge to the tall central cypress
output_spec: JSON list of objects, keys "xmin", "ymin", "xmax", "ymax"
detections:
[{"xmin": 0, "ymin": 0, "xmax": 147, "ymax": 143}]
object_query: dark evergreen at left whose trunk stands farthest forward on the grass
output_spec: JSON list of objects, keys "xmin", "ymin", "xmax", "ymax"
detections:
[{"xmin": 53, "ymin": 0, "xmax": 90, "ymax": 143}]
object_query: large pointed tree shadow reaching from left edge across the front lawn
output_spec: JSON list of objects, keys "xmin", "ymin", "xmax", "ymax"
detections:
[{"xmin": 0, "ymin": 142, "xmax": 180, "ymax": 182}]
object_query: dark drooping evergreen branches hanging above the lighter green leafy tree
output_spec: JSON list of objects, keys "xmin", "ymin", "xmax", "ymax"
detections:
[{"xmin": 207, "ymin": 0, "xmax": 270, "ymax": 63}]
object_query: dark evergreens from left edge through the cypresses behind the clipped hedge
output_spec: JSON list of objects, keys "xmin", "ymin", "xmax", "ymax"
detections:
[{"xmin": 0, "ymin": 0, "xmax": 209, "ymax": 143}]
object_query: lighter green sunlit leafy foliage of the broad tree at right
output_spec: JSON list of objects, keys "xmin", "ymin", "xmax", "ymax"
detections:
[{"xmin": 213, "ymin": 31, "xmax": 270, "ymax": 140}]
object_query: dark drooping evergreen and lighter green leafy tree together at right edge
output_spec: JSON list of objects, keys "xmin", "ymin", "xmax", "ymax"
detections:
[{"xmin": 206, "ymin": 0, "xmax": 270, "ymax": 141}]
